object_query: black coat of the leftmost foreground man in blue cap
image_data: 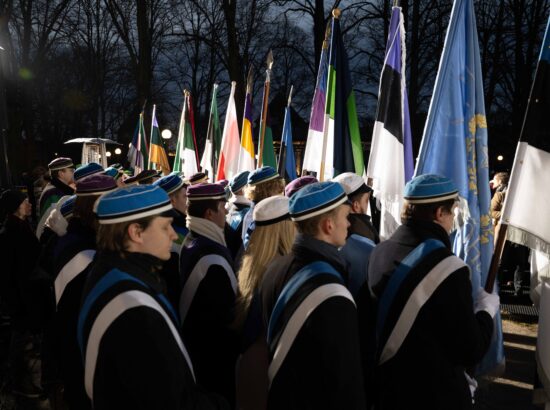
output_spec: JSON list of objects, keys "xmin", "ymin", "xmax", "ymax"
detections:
[{"xmin": 83, "ymin": 253, "xmax": 227, "ymax": 410}]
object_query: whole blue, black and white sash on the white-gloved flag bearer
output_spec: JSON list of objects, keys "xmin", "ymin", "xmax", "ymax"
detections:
[{"xmin": 376, "ymin": 239, "xmax": 467, "ymax": 364}]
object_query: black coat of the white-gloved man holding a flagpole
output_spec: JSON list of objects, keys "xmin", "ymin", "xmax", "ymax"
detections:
[{"xmin": 364, "ymin": 222, "xmax": 493, "ymax": 410}]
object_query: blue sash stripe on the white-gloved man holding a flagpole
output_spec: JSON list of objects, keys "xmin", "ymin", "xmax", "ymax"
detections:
[{"xmin": 376, "ymin": 239, "xmax": 445, "ymax": 336}]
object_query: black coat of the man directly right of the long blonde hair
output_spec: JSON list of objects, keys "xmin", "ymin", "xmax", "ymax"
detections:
[{"xmin": 261, "ymin": 235, "xmax": 366, "ymax": 410}]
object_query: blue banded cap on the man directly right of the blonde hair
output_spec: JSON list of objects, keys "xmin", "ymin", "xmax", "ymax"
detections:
[{"xmin": 289, "ymin": 181, "xmax": 350, "ymax": 221}]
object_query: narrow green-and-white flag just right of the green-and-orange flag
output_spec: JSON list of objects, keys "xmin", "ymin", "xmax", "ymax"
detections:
[{"xmin": 174, "ymin": 90, "xmax": 199, "ymax": 178}]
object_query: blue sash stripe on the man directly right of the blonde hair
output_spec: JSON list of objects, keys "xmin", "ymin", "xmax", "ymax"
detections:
[{"xmin": 267, "ymin": 261, "xmax": 342, "ymax": 343}]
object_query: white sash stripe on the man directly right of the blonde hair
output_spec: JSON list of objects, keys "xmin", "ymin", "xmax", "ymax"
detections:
[{"xmin": 267, "ymin": 283, "xmax": 355, "ymax": 387}]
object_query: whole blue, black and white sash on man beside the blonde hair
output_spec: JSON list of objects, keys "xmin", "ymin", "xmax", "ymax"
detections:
[{"xmin": 267, "ymin": 261, "xmax": 355, "ymax": 386}]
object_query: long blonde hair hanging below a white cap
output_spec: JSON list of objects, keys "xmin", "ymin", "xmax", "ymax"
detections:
[{"xmin": 237, "ymin": 219, "xmax": 296, "ymax": 324}]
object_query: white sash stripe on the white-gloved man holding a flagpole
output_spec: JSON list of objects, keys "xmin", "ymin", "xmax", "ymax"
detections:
[{"xmin": 379, "ymin": 255, "xmax": 467, "ymax": 364}]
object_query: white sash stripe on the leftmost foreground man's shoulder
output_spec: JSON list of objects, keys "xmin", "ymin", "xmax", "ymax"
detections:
[{"xmin": 84, "ymin": 290, "xmax": 195, "ymax": 401}]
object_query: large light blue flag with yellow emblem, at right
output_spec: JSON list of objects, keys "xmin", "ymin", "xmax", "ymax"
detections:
[{"xmin": 415, "ymin": 0, "xmax": 504, "ymax": 373}]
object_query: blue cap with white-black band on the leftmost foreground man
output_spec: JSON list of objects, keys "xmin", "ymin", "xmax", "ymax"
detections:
[{"xmin": 94, "ymin": 185, "xmax": 173, "ymax": 225}]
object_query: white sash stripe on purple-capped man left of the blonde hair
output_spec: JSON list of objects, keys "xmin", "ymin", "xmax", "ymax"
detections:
[{"xmin": 180, "ymin": 254, "xmax": 237, "ymax": 325}]
